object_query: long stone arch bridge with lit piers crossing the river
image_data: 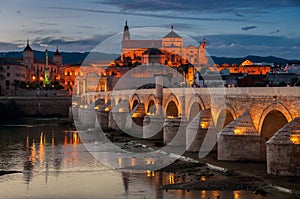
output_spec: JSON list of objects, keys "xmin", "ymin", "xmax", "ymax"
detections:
[{"xmin": 73, "ymin": 86, "xmax": 300, "ymax": 175}]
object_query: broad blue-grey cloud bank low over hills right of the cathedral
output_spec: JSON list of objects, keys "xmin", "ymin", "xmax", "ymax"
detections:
[{"xmin": 204, "ymin": 34, "xmax": 300, "ymax": 60}]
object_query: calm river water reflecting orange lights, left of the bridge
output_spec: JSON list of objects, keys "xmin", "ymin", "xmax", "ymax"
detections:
[{"xmin": 0, "ymin": 119, "xmax": 296, "ymax": 199}]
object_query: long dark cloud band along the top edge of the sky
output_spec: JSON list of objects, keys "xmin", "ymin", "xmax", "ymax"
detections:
[{"xmin": 95, "ymin": 0, "xmax": 300, "ymax": 12}]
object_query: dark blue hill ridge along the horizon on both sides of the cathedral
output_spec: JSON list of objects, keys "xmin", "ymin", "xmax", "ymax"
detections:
[{"xmin": 0, "ymin": 51, "xmax": 300, "ymax": 65}]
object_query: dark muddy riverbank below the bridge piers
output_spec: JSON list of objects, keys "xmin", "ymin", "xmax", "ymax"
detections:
[{"xmin": 106, "ymin": 130, "xmax": 300, "ymax": 198}]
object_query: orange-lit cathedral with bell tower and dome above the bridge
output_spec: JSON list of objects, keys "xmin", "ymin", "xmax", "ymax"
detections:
[{"xmin": 121, "ymin": 21, "xmax": 208, "ymax": 67}]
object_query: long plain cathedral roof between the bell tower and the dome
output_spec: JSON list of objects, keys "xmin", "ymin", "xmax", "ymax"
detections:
[{"xmin": 122, "ymin": 40, "xmax": 162, "ymax": 48}]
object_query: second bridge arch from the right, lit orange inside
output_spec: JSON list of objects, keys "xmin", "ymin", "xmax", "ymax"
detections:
[{"xmin": 215, "ymin": 103, "xmax": 237, "ymax": 129}]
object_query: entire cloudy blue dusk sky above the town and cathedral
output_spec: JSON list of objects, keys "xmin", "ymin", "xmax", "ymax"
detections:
[{"xmin": 0, "ymin": 0, "xmax": 300, "ymax": 59}]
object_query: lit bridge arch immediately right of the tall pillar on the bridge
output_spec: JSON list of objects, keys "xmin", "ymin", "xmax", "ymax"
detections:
[{"xmin": 164, "ymin": 94, "xmax": 181, "ymax": 117}]
